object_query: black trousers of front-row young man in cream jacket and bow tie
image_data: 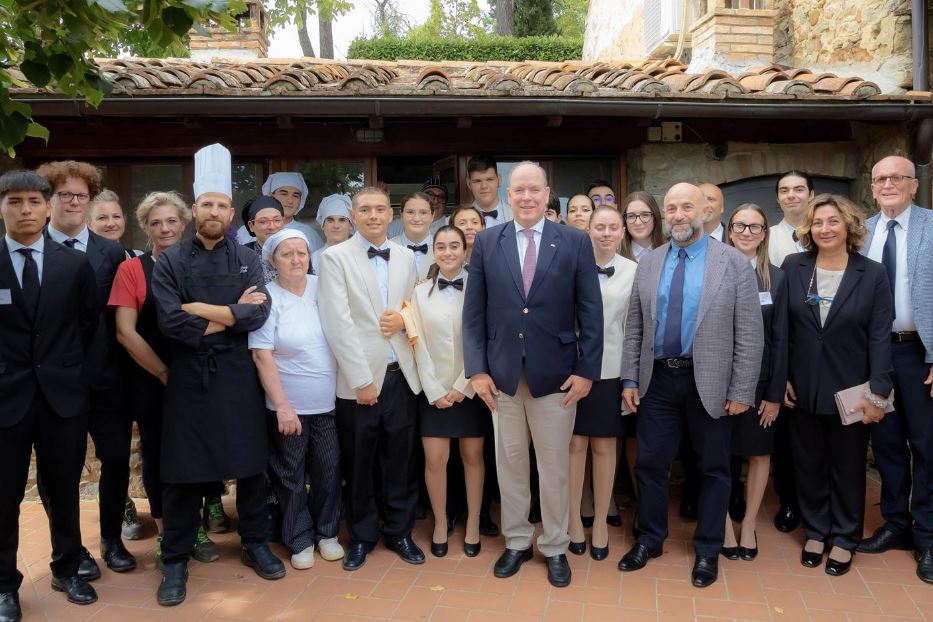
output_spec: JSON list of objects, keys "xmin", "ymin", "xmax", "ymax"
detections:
[{"xmin": 337, "ymin": 370, "xmax": 420, "ymax": 544}]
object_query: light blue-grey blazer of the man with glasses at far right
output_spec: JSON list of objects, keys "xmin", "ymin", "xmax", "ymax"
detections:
[{"xmin": 862, "ymin": 205, "xmax": 933, "ymax": 363}]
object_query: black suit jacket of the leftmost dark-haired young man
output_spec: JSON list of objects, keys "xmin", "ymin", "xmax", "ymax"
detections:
[{"xmin": 0, "ymin": 236, "xmax": 100, "ymax": 428}]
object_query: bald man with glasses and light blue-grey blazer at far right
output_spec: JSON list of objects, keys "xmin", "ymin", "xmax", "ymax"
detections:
[{"xmin": 858, "ymin": 156, "xmax": 933, "ymax": 583}]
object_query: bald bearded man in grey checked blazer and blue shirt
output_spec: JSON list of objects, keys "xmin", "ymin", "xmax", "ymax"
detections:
[{"xmin": 619, "ymin": 183, "xmax": 764, "ymax": 587}]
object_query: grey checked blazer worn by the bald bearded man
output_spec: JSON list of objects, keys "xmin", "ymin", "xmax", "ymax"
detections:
[{"xmin": 622, "ymin": 239, "xmax": 764, "ymax": 419}]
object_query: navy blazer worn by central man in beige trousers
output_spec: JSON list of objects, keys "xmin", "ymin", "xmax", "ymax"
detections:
[{"xmin": 463, "ymin": 221, "xmax": 603, "ymax": 397}]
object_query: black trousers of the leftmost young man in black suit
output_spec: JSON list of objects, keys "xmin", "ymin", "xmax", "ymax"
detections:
[{"xmin": 0, "ymin": 388, "xmax": 87, "ymax": 592}]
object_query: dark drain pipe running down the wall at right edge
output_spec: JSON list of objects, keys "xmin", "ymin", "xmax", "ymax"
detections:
[{"xmin": 910, "ymin": 0, "xmax": 933, "ymax": 208}]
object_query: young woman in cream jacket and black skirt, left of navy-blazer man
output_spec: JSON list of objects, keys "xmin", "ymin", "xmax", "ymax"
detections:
[{"xmin": 411, "ymin": 225, "xmax": 492, "ymax": 557}]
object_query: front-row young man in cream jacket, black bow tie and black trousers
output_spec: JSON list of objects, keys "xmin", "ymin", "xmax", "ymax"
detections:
[{"xmin": 318, "ymin": 187, "xmax": 424, "ymax": 570}]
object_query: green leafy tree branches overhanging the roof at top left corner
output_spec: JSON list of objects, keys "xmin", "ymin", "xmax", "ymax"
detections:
[{"xmin": 0, "ymin": 0, "xmax": 244, "ymax": 156}]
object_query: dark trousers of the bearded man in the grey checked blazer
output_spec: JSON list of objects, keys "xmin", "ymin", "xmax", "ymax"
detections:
[{"xmin": 635, "ymin": 364, "xmax": 732, "ymax": 557}]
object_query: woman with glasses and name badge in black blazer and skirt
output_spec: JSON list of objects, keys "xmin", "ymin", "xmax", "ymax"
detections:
[{"xmin": 722, "ymin": 203, "xmax": 787, "ymax": 561}]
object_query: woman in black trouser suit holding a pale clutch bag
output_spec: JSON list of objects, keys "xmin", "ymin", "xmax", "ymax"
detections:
[{"xmin": 783, "ymin": 194, "xmax": 893, "ymax": 576}]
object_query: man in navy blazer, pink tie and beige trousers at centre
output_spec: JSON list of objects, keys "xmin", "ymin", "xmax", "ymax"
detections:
[{"xmin": 463, "ymin": 162, "xmax": 603, "ymax": 587}]
